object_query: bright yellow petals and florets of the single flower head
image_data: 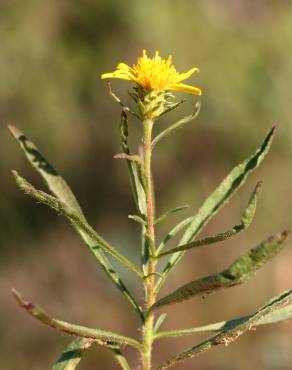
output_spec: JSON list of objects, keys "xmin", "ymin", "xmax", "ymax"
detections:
[{"xmin": 101, "ymin": 50, "xmax": 202, "ymax": 95}]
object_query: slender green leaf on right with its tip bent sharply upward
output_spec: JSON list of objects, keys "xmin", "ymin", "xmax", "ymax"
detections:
[{"xmin": 158, "ymin": 181, "xmax": 263, "ymax": 257}]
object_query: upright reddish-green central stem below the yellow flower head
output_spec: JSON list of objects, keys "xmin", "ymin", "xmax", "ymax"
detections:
[{"xmin": 142, "ymin": 119, "xmax": 155, "ymax": 370}]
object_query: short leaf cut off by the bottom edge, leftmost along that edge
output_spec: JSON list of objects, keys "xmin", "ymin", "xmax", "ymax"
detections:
[{"xmin": 52, "ymin": 338, "xmax": 94, "ymax": 370}]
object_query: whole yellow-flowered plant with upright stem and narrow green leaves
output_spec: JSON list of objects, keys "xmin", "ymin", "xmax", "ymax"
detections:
[{"xmin": 9, "ymin": 50, "xmax": 292, "ymax": 370}]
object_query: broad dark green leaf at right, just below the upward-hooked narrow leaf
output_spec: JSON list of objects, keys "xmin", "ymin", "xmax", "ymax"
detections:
[{"xmin": 152, "ymin": 231, "xmax": 289, "ymax": 309}]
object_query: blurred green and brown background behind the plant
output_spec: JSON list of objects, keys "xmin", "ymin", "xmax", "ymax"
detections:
[{"xmin": 0, "ymin": 0, "xmax": 292, "ymax": 370}]
